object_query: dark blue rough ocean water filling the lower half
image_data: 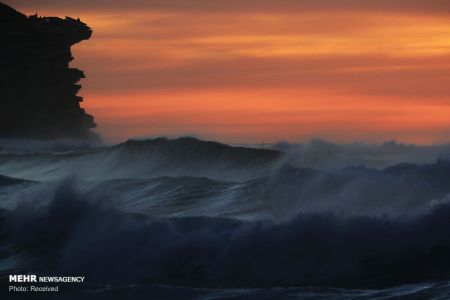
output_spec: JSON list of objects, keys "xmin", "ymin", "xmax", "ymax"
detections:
[{"xmin": 0, "ymin": 138, "xmax": 450, "ymax": 299}]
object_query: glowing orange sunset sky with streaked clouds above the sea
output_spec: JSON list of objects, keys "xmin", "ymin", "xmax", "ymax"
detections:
[{"xmin": 4, "ymin": 0, "xmax": 450, "ymax": 144}]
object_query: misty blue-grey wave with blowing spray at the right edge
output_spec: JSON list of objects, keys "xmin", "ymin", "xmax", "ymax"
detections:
[{"xmin": 266, "ymin": 160, "xmax": 450, "ymax": 219}]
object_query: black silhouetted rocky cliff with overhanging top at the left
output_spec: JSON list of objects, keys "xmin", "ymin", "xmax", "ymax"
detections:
[{"xmin": 0, "ymin": 3, "xmax": 96, "ymax": 139}]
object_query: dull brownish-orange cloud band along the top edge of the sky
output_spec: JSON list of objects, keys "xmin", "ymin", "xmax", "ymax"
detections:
[{"xmin": 6, "ymin": 0, "xmax": 450, "ymax": 14}]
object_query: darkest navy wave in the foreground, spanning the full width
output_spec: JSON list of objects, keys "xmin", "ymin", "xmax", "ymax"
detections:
[{"xmin": 3, "ymin": 182, "xmax": 450, "ymax": 288}]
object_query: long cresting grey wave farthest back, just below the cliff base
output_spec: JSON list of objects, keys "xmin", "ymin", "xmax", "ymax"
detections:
[{"xmin": 0, "ymin": 138, "xmax": 282, "ymax": 181}]
